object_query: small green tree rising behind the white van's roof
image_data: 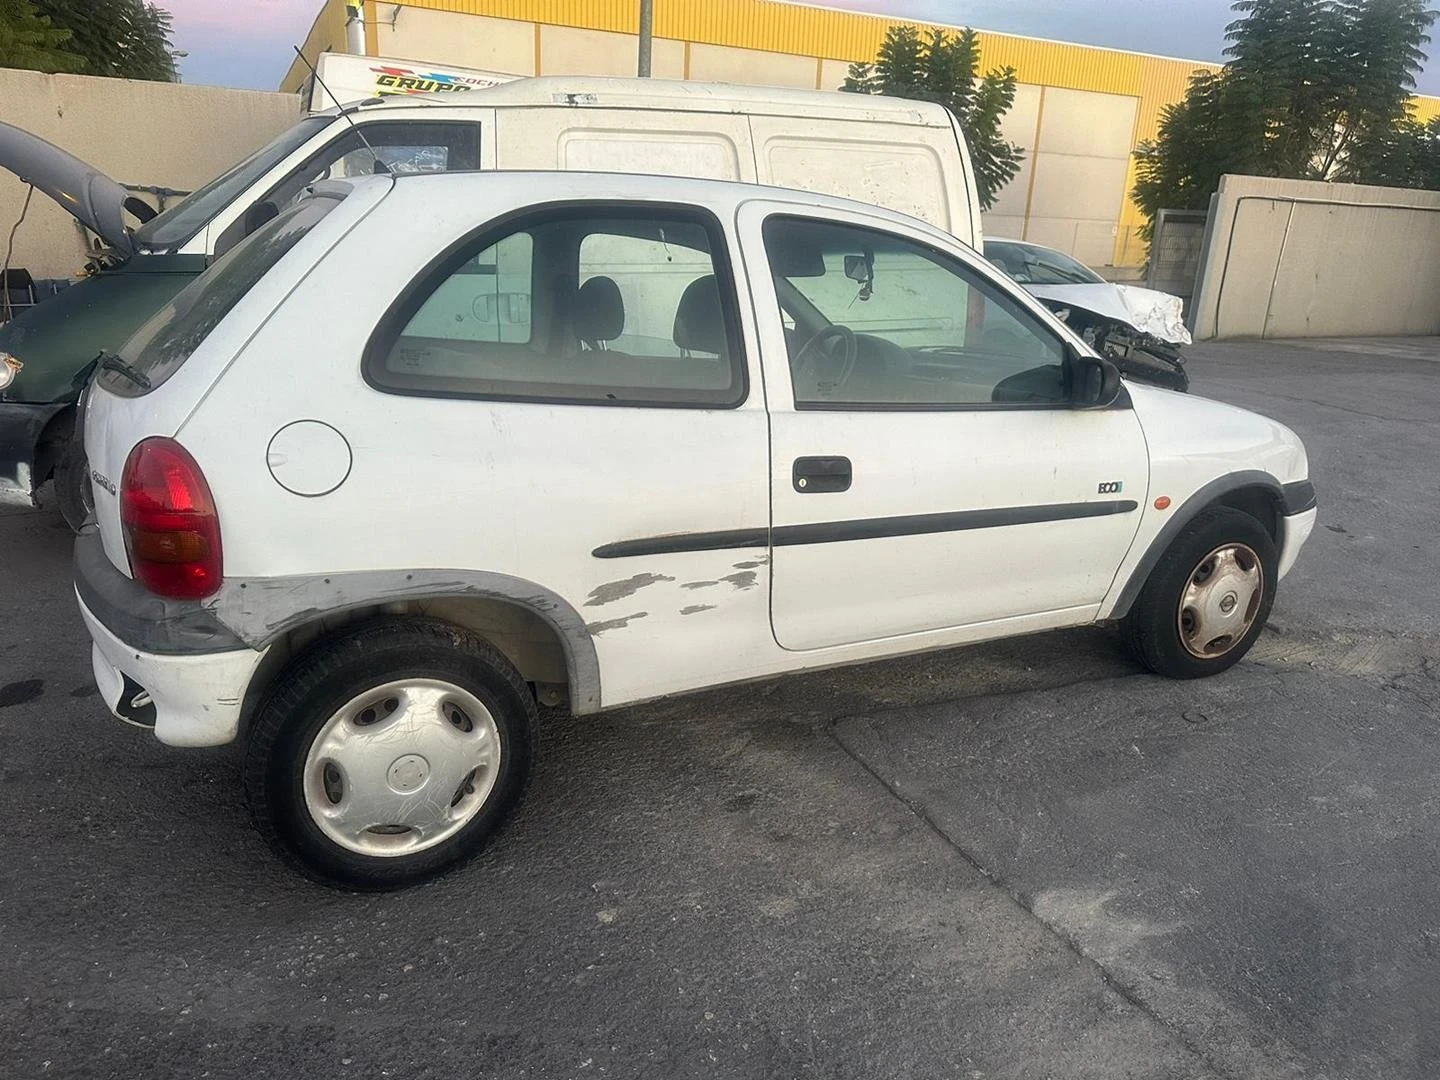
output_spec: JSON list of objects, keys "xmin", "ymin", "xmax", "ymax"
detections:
[{"xmin": 841, "ymin": 26, "xmax": 1024, "ymax": 210}]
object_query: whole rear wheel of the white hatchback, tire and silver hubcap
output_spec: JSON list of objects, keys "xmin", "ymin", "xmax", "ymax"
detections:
[{"xmin": 245, "ymin": 619, "xmax": 536, "ymax": 890}]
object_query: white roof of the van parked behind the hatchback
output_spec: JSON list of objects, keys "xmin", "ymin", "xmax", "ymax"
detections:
[{"xmin": 347, "ymin": 75, "xmax": 950, "ymax": 128}]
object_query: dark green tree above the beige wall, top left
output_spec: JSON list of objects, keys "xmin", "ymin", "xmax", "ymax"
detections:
[{"xmin": 33, "ymin": 0, "xmax": 176, "ymax": 82}]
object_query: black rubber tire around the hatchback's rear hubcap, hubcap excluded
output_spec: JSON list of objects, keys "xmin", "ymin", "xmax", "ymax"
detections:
[{"xmin": 243, "ymin": 618, "xmax": 537, "ymax": 891}]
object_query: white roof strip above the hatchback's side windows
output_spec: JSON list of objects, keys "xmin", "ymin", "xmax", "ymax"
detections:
[{"xmin": 365, "ymin": 168, "xmax": 966, "ymax": 246}]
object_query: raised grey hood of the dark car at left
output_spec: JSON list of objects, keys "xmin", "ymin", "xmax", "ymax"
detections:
[{"xmin": 0, "ymin": 124, "xmax": 154, "ymax": 255}]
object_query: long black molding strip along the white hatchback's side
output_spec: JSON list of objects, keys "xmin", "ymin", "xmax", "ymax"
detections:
[{"xmin": 590, "ymin": 498, "xmax": 1138, "ymax": 559}]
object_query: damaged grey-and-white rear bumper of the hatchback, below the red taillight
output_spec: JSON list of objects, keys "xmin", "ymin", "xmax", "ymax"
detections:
[{"xmin": 75, "ymin": 526, "xmax": 265, "ymax": 746}]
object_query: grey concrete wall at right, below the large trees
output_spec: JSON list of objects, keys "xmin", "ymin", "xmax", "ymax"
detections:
[{"xmin": 1191, "ymin": 176, "xmax": 1440, "ymax": 338}]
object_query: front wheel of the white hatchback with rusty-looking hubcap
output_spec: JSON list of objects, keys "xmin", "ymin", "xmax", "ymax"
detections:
[{"xmin": 1123, "ymin": 507, "xmax": 1277, "ymax": 678}]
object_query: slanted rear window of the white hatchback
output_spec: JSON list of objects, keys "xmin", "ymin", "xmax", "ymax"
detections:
[{"xmin": 98, "ymin": 194, "xmax": 340, "ymax": 397}]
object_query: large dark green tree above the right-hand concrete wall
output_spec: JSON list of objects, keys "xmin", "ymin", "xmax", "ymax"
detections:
[{"xmin": 1133, "ymin": 0, "xmax": 1436, "ymax": 233}]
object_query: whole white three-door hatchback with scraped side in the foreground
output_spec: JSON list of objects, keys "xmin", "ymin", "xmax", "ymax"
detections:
[{"xmin": 76, "ymin": 173, "xmax": 1315, "ymax": 888}]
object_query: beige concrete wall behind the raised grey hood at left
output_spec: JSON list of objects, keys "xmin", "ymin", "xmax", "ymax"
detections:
[{"xmin": 0, "ymin": 68, "xmax": 300, "ymax": 278}]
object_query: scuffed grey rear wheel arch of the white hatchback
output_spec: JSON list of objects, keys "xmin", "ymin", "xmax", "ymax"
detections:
[{"xmin": 207, "ymin": 570, "xmax": 600, "ymax": 730}]
